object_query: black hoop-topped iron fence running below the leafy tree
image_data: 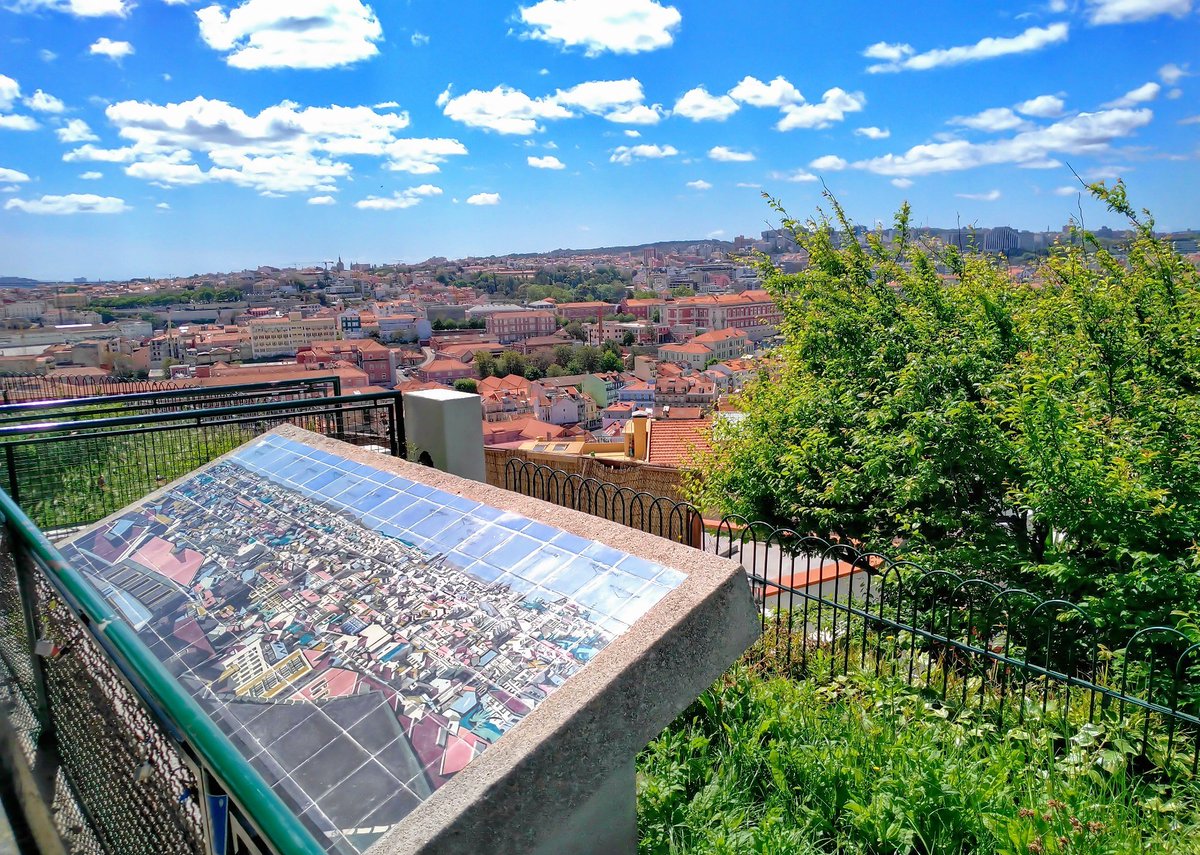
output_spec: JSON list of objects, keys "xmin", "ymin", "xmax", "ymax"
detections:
[{"xmin": 496, "ymin": 460, "xmax": 1200, "ymax": 775}]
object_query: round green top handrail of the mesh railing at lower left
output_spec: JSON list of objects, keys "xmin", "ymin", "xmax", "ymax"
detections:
[{"xmin": 0, "ymin": 490, "xmax": 325, "ymax": 855}]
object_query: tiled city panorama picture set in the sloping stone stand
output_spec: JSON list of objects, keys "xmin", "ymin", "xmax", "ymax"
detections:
[{"xmin": 62, "ymin": 434, "xmax": 684, "ymax": 853}]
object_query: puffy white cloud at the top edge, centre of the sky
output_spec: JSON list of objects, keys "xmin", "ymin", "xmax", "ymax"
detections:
[{"xmin": 518, "ymin": 0, "xmax": 683, "ymax": 56}]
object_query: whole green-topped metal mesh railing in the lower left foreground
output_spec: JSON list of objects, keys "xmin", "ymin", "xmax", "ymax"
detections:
[{"xmin": 0, "ymin": 491, "xmax": 325, "ymax": 855}]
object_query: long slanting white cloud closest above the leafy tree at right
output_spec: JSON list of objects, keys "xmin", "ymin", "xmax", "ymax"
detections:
[{"xmin": 852, "ymin": 109, "xmax": 1154, "ymax": 177}]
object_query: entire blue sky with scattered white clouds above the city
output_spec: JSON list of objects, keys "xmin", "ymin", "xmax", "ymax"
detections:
[{"xmin": 0, "ymin": 0, "xmax": 1200, "ymax": 279}]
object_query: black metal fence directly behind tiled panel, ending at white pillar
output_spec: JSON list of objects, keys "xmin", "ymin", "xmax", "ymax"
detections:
[{"xmin": 0, "ymin": 391, "xmax": 406, "ymax": 532}]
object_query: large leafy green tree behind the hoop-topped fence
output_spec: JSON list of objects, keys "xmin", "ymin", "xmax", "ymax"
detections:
[{"xmin": 697, "ymin": 183, "xmax": 1200, "ymax": 638}]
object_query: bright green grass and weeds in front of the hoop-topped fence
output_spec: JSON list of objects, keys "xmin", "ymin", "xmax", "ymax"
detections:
[{"xmin": 637, "ymin": 666, "xmax": 1200, "ymax": 855}]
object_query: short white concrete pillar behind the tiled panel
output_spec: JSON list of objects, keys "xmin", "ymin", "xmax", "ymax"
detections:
[{"xmin": 404, "ymin": 389, "xmax": 486, "ymax": 482}]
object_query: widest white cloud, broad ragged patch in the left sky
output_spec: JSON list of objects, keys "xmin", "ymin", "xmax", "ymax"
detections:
[{"xmin": 64, "ymin": 97, "xmax": 467, "ymax": 193}]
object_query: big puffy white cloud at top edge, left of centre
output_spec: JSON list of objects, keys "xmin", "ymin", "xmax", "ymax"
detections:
[{"xmin": 196, "ymin": 0, "xmax": 383, "ymax": 68}]
